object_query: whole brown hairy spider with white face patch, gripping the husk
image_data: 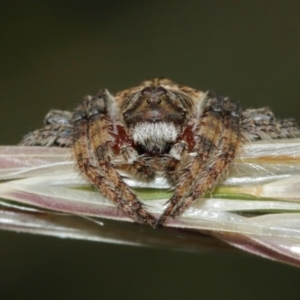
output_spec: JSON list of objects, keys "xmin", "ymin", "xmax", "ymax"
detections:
[{"xmin": 21, "ymin": 78, "xmax": 300, "ymax": 227}]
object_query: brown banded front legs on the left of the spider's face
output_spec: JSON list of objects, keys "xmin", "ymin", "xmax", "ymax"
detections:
[{"xmin": 73, "ymin": 90, "xmax": 157, "ymax": 227}]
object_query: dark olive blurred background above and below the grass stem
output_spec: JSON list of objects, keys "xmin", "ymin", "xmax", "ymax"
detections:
[{"xmin": 0, "ymin": 0, "xmax": 300, "ymax": 300}]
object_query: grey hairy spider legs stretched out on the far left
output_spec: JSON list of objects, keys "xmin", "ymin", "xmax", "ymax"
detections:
[{"xmin": 19, "ymin": 110, "xmax": 73, "ymax": 147}]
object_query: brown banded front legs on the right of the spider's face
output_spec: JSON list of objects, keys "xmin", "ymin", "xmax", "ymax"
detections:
[{"xmin": 158, "ymin": 92, "xmax": 243, "ymax": 225}]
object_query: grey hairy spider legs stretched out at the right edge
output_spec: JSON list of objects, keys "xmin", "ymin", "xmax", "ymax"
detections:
[{"xmin": 241, "ymin": 107, "xmax": 300, "ymax": 141}]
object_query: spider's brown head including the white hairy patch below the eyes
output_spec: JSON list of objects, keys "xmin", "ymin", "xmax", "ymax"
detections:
[{"xmin": 122, "ymin": 85, "xmax": 191, "ymax": 153}]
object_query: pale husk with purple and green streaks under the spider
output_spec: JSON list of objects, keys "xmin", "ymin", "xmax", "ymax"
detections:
[{"xmin": 0, "ymin": 139, "xmax": 300, "ymax": 266}]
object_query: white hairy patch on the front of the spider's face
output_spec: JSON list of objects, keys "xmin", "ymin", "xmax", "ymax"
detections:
[{"xmin": 132, "ymin": 122, "xmax": 178, "ymax": 152}]
